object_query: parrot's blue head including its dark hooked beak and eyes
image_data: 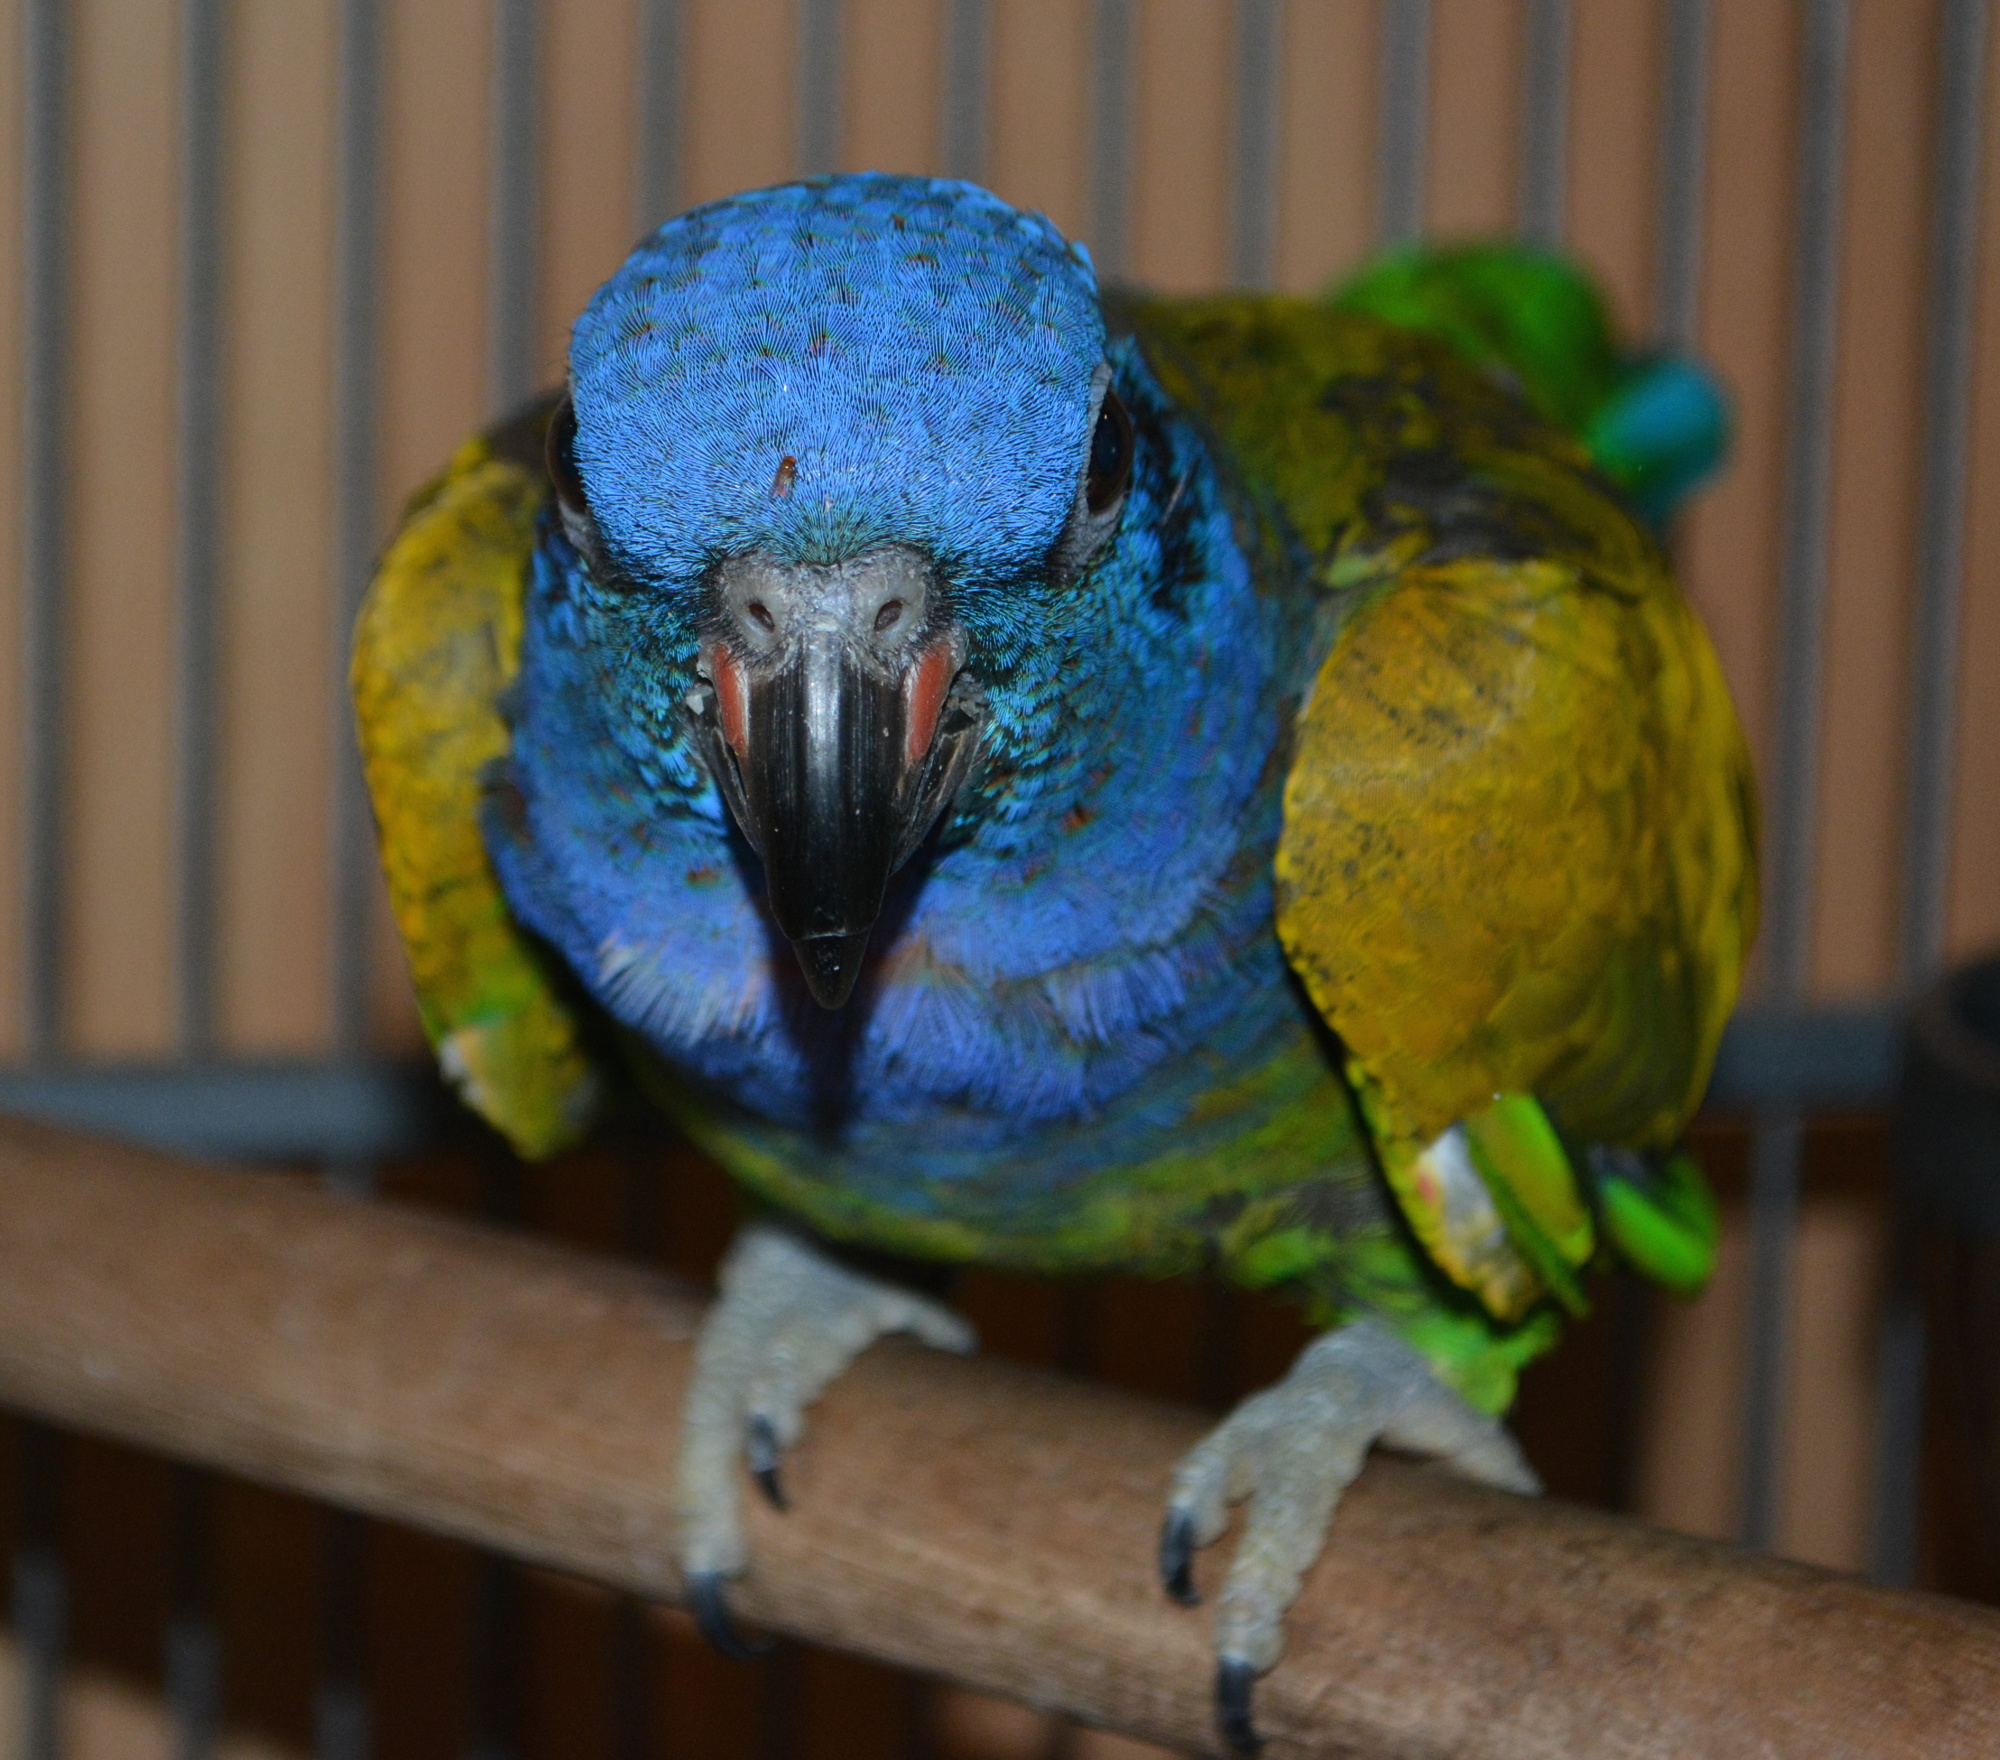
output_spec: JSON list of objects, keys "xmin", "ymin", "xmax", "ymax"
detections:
[{"xmin": 548, "ymin": 174, "xmax": 1134, "ymax": 1008}]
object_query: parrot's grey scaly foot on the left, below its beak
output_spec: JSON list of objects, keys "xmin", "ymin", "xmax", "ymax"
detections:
[{"xmin": 674, "ymin": 1222, "xmax": 978, "ymax": 1656}]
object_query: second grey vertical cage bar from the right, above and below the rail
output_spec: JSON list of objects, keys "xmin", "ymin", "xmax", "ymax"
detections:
[{"xmin": 1742, "ymin": 0, "xmax": 1848, "ymax": 1546}]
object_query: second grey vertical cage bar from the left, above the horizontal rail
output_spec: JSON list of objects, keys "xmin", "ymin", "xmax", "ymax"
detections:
[{"xmin": 174, "ymin": 0, "xmax": 224, "ymax": 1058}]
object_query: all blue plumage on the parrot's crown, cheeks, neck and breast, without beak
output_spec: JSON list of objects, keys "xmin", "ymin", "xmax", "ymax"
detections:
[{"xmin": 486, "ymin": 176, "xmax": 1298, "ymax": 1180}]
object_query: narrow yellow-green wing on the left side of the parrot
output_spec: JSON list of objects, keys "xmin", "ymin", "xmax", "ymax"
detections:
[{"xmin": 352, "ymin": 422, "xmax": 602, "ymax": 1158}]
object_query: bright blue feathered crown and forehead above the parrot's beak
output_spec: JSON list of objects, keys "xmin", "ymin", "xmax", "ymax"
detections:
[{"xmin": 570, "ymin": 172, "xmax": 1104, "ymax": 588}]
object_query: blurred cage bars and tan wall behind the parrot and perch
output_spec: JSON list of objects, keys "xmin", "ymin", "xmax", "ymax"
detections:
[{"xmin": 0, "ymin": 0, "xmax": 2000, "ymax": 1760}]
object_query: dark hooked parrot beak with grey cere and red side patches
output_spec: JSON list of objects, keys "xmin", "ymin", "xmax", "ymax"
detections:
[{"xmin": 688, "ymin": 546, "xmax": 986, "ymax": 1008}]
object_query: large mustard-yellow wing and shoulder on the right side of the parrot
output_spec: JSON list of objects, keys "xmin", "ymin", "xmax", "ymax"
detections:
[{"xmin": 1134, "ymin": 298, "xmax": 1756, "ymax": 1320}]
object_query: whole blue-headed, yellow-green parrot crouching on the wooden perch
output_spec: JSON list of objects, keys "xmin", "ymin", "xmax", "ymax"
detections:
[{"xmin": 352, "ymin": 172, "xmax": 1756, "ymax": 1754}]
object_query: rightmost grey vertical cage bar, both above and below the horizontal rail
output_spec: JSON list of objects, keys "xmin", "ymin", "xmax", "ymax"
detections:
[{"xmin": 1868, "ymin": 0, "xmax": 1988, "ymax": 1584}]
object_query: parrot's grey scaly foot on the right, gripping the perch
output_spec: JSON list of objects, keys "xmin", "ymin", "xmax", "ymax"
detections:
[{"xmin": 1160, "ymin": 1320, "xmax": 1542, "ymax": 1756}]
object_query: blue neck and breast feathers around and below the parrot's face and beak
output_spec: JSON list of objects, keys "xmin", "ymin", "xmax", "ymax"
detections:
[{"xmin": 486, "ymin": 408, "xmax": 1288, "ymax": 1136}]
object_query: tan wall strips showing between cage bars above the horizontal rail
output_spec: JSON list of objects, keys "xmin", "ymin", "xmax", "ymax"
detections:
[{"xmin": 0, "ymin": 0, "xmax": 2000, "ymax": 1056}]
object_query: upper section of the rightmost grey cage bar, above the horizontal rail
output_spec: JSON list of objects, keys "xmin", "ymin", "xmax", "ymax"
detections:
[{"xmin": 1902, "ymin": 0, "xmax": 1986, "ymax": 986}]
